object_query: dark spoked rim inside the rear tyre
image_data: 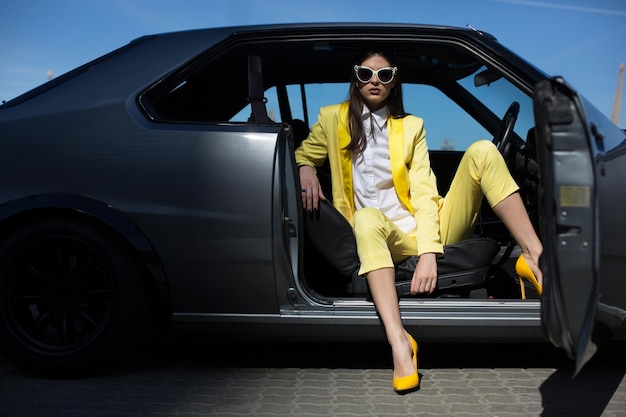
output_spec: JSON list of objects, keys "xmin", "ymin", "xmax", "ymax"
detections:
[{"xmin": 3, "ymin": 235, "xmax": 115, "ymax": 355}]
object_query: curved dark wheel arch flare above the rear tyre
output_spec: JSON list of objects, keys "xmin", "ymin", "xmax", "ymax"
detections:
[{"xmin": 0, "ymin": 193, "xmax": 172, "ymax": 319}]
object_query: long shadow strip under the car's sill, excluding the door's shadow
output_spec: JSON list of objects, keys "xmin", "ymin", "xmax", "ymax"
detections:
[{"xmin": 123, "ymin": 336, "xmax": 570, "ymax": 372}]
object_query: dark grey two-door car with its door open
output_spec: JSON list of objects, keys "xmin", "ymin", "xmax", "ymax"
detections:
[{"xmin": 0, "ymin": 24, "xmax": 626, "ymax": 374}]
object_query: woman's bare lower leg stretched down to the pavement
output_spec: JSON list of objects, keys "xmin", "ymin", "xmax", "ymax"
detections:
[{"xmin": 367, "ymin": 268, "xmax": 415, "ymax": 377}]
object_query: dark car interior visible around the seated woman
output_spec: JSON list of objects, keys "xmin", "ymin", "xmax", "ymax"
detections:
[{"xmin": 140, "ymin": 34, "xmax": 538, "ymax": 299}]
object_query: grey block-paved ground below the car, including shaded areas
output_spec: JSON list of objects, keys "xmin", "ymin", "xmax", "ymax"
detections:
[{"xmin": 0, "ymin": 336, "xmax": 626, "ymax": 417}]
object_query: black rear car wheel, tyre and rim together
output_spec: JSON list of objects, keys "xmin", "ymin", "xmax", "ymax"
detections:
[{"xmin": 0, "ymin": 219, "xmax": 147, "ymax": 375}]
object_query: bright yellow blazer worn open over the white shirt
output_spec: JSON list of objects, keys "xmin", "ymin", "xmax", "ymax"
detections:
[{"xmin": 295, "ymin": 102, "xmax": 443, "ymax": 254}]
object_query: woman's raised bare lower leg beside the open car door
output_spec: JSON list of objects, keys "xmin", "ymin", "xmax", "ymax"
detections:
[{"xmin": 493, "ymin": 193, "xmax": 543, "ymax": 285}]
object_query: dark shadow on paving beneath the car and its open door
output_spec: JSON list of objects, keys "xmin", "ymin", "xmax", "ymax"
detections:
[{"xmin": 127, "ymin": 339, "xmax": 626, "ymax": 417}]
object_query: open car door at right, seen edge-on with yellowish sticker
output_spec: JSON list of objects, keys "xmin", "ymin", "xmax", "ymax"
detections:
[{"xmin": 534, "ymin": 78, "xmax": 625, "ymax": 373}]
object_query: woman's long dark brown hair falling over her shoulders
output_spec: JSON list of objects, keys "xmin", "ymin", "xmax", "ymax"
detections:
[{"xmin": 346, "ymin": 51, "xmax": 407, "ymax": 152}]
